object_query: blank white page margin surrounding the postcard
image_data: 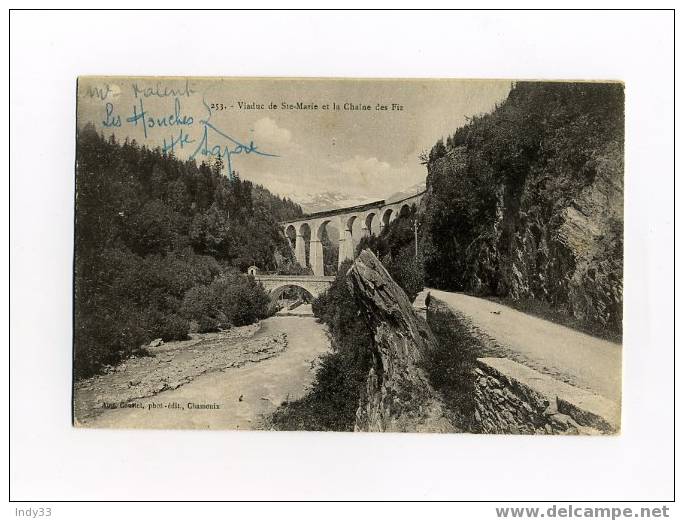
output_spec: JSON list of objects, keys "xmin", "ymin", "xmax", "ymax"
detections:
[{"xmin": 3, "ymin": 7, "xmax": 674, "ymax": 519}]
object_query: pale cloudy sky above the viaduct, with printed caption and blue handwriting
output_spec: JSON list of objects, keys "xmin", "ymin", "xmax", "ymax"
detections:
[{"xmin": 77, "ymin": 77, "xmax": 511, "ymax": 206}]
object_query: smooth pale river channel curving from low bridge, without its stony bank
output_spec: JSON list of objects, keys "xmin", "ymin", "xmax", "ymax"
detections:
[{"xmin": 88, "ymin": 316, "xmax": 329, "ymax": 429}]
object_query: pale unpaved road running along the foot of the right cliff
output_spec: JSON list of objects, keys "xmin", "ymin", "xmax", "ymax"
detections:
[{"xmin": 427, "ymin": 289, "xmax": 622, "ymax": 403}]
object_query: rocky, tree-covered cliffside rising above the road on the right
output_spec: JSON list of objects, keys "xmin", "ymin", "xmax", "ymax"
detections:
[{"xmin": 421, "ymin": 82, "xmax": 624, "ymax": 334}]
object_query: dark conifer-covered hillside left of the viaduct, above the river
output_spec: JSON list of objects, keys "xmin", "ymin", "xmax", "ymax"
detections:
[{"xmin": 74, "ymin": 126, "xmax": 302, "ymax": 377}]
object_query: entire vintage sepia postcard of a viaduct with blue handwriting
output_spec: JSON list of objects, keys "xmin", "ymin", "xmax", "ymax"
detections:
[{"xmin": 73, "ymin": 77, "xmax": 624, "ymax": 435}]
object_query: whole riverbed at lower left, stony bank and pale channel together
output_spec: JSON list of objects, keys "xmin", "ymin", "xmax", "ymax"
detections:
[{"xmin": 74, "ymin": 317, "xmax": 329, "ymax": 429}]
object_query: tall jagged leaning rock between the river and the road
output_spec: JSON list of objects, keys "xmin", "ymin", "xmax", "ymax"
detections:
[{"xmin": 347, "ymin": 250, "xmax": 456, "ymax": 432}]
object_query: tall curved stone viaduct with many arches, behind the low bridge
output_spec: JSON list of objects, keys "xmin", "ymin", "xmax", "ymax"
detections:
[{"xmin": 280, "ymin": 192, "xmax": 425, "ymax": 277}]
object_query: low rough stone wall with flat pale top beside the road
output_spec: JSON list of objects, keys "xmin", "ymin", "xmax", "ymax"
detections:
[{"xmin": 473, "ymin": 358, "xmax": 619, "ymax": 434}]
